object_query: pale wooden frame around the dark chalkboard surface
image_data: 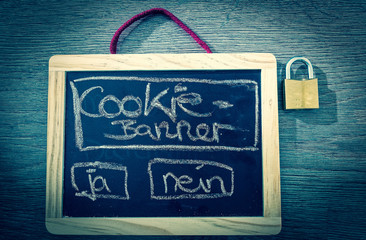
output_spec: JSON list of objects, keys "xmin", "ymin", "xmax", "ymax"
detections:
[{"xmin": 46, "ymin": 53, "xmax": 281, "ymax": 235}]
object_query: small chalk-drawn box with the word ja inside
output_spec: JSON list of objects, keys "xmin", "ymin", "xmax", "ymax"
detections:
[{"xmin": 71, "ymin": 162, "xmax": 129, "ymax": 201}]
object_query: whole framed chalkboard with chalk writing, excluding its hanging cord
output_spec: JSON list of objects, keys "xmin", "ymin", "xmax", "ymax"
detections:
[{"xmin": 46, "ymin": 54, "xmax": 281, "ymax": 235}]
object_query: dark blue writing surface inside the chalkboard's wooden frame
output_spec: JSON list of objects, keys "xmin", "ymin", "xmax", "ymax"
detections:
[{"xmin": 63, "ymin": 70, "xmax": 263, "ymax": 217}]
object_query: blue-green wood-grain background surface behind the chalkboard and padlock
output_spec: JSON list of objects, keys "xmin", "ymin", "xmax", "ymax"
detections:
[{"xmin": 0, "ymin": 0, "xmax": 366, "ymax": 240}]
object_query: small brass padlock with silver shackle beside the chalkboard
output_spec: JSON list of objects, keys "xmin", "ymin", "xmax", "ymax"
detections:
[{"xmin": 283, "ymin": 57, "xmax": 319, "ymax": 109}]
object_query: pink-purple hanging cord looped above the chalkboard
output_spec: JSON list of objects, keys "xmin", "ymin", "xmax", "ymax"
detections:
[{"xmin": 109, "ymin": 8, "xmax": 212, "ymax": 54}]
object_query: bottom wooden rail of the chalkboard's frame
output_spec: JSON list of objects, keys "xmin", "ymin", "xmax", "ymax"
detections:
[{"xmin": 47, "ymin": 217, "xmax": 281, "ymax": 235}]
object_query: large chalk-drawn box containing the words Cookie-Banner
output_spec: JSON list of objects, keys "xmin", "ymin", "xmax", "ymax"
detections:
[{"xmin": 70, "ymin": 76, "xmax": 259, "ymax": 151}]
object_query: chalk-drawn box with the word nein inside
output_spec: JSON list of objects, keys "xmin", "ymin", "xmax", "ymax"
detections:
[{"xmin": 148, "ymin": 158, "xmax": 234, "ymax": 200}]
